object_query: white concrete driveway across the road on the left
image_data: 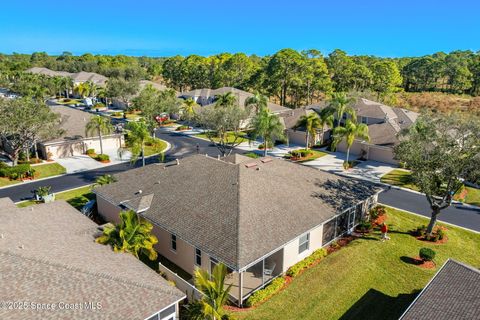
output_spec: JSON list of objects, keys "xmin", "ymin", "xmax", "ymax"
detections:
[{"xmin": 56, "ymin": 149, "xmax": 131, "ymax": 173}]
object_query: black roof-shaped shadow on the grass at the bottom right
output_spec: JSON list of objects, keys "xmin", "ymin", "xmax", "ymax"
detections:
[{"xmin": 340, "ymin": 289, "xmax": 420, "ymax": 320}]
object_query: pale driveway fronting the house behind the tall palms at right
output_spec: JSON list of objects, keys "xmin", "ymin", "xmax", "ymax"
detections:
[{"xmin": 303, "ymin": 150, "xmax": 397, "ymax": 182}]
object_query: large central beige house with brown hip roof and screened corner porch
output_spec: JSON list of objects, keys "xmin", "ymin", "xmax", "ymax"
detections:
[{"xmin": 94, "ymin": 154, "xmax": 380, "ymax": 305}]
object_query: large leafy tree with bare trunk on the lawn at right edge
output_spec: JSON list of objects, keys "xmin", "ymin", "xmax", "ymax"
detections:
[{"xmin": 394, "ymin": 114, "xmax": 480, "ymax": 235}]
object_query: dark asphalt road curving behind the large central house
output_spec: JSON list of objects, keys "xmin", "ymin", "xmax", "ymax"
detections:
[{"xmin": 0, "ymin": 132, "xmax": 480, "ymax": 232}]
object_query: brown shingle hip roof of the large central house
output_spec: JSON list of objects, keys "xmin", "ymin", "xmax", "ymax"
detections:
[{"xmin": 95, "ymin": 155, "xmax": 379, "ymax": 270}]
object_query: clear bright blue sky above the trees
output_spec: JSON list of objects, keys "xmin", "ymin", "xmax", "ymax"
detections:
[{"xmin": 0, "ymin": 0, "xmax": 480, "ymax": 57}]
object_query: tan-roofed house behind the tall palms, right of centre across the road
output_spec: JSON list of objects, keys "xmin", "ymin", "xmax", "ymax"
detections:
[{"xmin": 317, "ymin": 98, "xmax": 419, "ymax": 164}]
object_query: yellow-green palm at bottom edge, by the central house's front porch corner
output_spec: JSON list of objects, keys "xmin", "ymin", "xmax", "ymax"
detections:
[{"xmin": 194, "ymin": 263, "xmax": 232, "ymax": 320}]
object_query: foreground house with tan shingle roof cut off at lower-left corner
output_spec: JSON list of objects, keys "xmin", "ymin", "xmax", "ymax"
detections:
[{"xmin": 0, "ymin": 198, "xmax": 185, "ymax": 320}]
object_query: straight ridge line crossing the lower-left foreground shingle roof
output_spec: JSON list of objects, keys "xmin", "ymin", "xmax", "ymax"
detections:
[{"xmin": 0, "ymin": 250, "xmax": 179, "ymax": 295}]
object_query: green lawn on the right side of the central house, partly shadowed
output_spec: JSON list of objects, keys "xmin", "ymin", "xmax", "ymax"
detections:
[{"xmin": 235, "ymin": 209, "xmax": 480, "ymax": 320}]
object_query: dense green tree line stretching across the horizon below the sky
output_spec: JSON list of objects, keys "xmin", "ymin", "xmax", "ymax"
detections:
[{"xmin": 0, "ymin": 49, "xmax": 480, "ymax": 107}]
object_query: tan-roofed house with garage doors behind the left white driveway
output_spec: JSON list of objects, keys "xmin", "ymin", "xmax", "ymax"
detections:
[{"xmin": 38, "ymin": 105, "xmax": 124, "ymax": 159}]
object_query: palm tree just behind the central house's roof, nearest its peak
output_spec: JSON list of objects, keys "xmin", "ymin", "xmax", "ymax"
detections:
[{"xmin": 252, "ymin": 107, "xmax": 285, "ymax": 157}]
